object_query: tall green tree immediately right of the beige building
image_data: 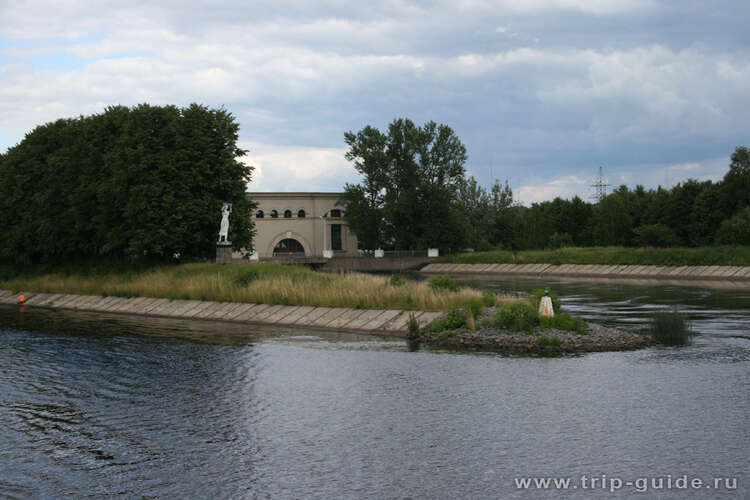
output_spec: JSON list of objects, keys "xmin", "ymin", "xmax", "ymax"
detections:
[{"xmin": 342, "ymin": 119, "xmax": 469, "ymax": 249}]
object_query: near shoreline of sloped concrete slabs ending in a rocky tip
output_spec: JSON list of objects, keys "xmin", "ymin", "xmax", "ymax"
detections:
[{"xmin": 0, "ymin": 289, "xmax": 654, "ymax": 356}]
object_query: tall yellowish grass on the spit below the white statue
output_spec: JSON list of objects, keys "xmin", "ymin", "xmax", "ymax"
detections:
[{"xmin": 0, "ymin": 264, "xmax": 506, "ymax": 311}]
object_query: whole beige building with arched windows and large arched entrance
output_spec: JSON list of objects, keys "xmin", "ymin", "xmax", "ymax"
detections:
[{"xmin": 248, "ymin": 193, "xmax": 357, "ymax": 258}]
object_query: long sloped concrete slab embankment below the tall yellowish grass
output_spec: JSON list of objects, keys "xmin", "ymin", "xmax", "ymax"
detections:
[{"xmin": 0, "ymin": 290, "xmax": 441, "ymax": 336}]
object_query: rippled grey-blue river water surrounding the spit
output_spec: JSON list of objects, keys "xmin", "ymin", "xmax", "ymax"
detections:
[{"xmin": 0, "ymin": 280, "xmax": 750, "ymax": 499}]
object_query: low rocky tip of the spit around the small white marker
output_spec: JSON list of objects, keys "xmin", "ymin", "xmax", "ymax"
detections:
[{"xmin": 420, "ymin": 323, "xmax": 654, "ymax": 355}]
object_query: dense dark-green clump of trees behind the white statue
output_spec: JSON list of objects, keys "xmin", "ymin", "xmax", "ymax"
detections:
[{"xmin": 0, "ymin": 104, "xmax": 253, "ymax": 263}]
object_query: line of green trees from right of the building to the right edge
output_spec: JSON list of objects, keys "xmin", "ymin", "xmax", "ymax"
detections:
[{"xmin": 342, "ymin": 119, "xmax": 750, "ymax": 250}]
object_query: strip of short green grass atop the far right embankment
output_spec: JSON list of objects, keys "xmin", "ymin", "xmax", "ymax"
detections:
[{"xmin": 440, "ymin": 247, "xmax": 750, "ymax": 266}]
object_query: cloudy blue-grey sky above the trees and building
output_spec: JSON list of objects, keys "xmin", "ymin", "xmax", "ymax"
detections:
[{"xmin": 0, "ymin": 0, "xmax": 750, "ymax": 205}]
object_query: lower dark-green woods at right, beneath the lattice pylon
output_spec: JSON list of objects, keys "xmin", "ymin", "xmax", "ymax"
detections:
[{"xmin": 502, "ymin": 147, "xmax": 750, "ymax": 249}]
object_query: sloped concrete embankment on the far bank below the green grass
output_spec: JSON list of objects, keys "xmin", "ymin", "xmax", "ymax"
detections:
[{"xmin": 421, "ymin": 264, "xmax": 750, "ymax": 281}]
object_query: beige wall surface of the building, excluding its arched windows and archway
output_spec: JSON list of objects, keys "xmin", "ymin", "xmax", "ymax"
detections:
[{"xmin": 249, "ymin": 193, "xmax": 357, "ymax": 257}]
